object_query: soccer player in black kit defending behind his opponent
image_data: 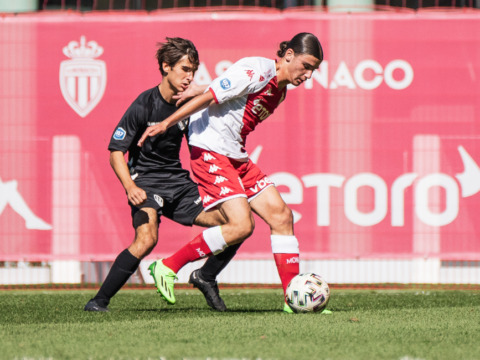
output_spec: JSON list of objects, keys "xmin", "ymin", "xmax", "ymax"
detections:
[{"xmin": 84, "ymin": 38, "xmax": 239, "ymax": 312}]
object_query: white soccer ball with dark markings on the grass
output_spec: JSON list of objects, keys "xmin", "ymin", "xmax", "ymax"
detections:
[{"xmin": 285, "ymin": 273, "xmax": 330, "ymax": 313}]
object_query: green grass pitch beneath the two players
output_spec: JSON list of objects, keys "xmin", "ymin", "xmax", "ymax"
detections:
[{"xmin": 0, "ymin": 289, "xmax": 480, "ymax": 360}]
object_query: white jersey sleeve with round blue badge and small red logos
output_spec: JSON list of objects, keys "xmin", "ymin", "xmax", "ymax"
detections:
[{"xmin": 208, "ymin": 58, "xmax": 275, "ymax": 104}]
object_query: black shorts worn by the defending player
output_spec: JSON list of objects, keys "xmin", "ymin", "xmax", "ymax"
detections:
[{"xmin": 129, "ymin": 180, "xmax": 203, "ymax": 226}]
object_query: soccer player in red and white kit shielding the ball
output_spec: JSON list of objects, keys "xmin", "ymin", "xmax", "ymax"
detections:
[{"xmin": 139, "ymin": 33, "xmax": 323, "ymax": 312}]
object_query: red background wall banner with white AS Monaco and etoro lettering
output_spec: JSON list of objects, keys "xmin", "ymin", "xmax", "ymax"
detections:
[{"xmin": 0, "ymin": 0, "xmax": 480, "ymax": 285}]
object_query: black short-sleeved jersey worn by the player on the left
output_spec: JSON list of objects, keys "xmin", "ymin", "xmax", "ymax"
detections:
[{"xmin": 108, "ymin": 86, "xmax": 190, "ymax": 186}]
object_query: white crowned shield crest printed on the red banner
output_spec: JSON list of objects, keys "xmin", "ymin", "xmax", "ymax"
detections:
[{"xmin": 60, "ymin": 36, "xmax": 107, "ymax": 117}]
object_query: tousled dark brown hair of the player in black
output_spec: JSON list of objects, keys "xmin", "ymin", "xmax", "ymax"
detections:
[{"xmin": 155, "ymin": 37, "xmax": 200, "ymax": 75}]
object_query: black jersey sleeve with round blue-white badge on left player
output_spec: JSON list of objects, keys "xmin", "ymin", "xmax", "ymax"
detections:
[{"xmin": 108, "ymin": 104, "xmax": 146, "ymax": 153}]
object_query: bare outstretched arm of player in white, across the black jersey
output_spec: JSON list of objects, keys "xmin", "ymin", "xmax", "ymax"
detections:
[{"xmin": 137, "ymin": 91, "xmax": 214, "ymax": 146}]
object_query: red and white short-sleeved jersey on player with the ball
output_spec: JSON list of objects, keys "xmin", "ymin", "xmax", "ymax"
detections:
[{"xmin": 189, "ymin": 57, "xmax": 286, "ymax": 161}]
